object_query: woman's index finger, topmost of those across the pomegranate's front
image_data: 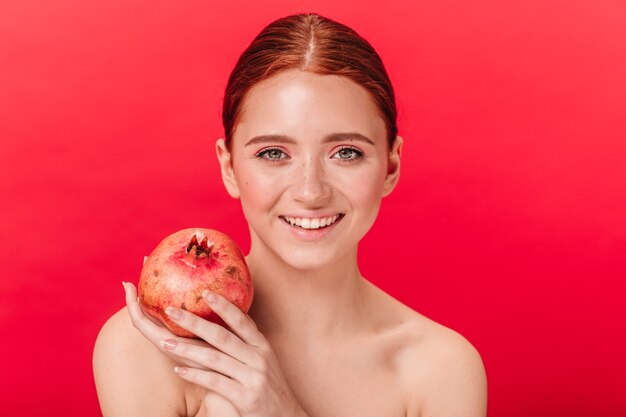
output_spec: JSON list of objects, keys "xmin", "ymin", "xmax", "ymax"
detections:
[{"xmin": 202, "ymin": 290, "xmax": 265, "ymax": 347}]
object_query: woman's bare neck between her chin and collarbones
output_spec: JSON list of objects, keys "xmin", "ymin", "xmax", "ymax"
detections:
[{"xmin": 246, "ymin": 240, "xmax": 366, "ymax": 344}]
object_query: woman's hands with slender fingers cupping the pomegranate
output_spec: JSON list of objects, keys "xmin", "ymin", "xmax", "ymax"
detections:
[{"xmin": 126, "ymin": 284, "xmax": 306, "ymax": 417}]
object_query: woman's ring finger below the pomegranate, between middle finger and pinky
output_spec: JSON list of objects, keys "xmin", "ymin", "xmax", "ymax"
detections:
[{"xmin": 162, "ymin": 339, "xmax": 251, "ymax": 383}]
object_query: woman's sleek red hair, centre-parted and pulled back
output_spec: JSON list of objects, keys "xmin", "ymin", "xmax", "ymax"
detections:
[{"xmin": 222, "ymin": 13, "xmax": 398, "ymax": 149}]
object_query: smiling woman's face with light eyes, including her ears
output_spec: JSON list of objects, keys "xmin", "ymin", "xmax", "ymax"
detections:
[{"xmin": 217, "ymin": 71, "xmax": 402, "ymax": 269}]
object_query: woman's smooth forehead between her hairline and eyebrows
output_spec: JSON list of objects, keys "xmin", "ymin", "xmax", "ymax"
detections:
[{"xmin": 234, "ymin": 70, "xmax": 386, "ymax": 142}]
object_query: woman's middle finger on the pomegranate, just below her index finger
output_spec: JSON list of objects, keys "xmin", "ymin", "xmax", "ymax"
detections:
[{"xmin": 165, "ymin": 307, "xmax": 258, "ymax": 366}]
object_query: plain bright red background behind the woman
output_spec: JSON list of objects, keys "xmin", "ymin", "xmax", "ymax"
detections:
[{"xmin": 0, "ymin": 0, "xmax": 626, "ymax": 417}]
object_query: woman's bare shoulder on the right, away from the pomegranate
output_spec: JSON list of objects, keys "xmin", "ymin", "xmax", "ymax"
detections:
[{"xmin": 364, "ymin": 282, "xmax": 487, "ymax": 417}]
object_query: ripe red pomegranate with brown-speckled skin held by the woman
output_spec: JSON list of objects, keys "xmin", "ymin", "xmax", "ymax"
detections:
[{"xmin": 138, "ymin": 228, "xmax": 254, "ymax": 338}]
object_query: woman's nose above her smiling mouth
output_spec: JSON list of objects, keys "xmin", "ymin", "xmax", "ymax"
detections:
[{"xmin": 291, "ymin": 157, "xmax": 332, "ymax": 204}]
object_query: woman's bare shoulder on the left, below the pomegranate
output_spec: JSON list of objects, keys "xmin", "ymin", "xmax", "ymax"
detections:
[{"xmin": 93, "ymin": 307, "xmax": 186, "ymax": 417}]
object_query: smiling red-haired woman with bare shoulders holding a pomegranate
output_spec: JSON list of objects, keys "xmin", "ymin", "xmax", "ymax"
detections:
[{"xmin": 94, "ymin": 14, "xmax": 486, "ymax": 417}]
